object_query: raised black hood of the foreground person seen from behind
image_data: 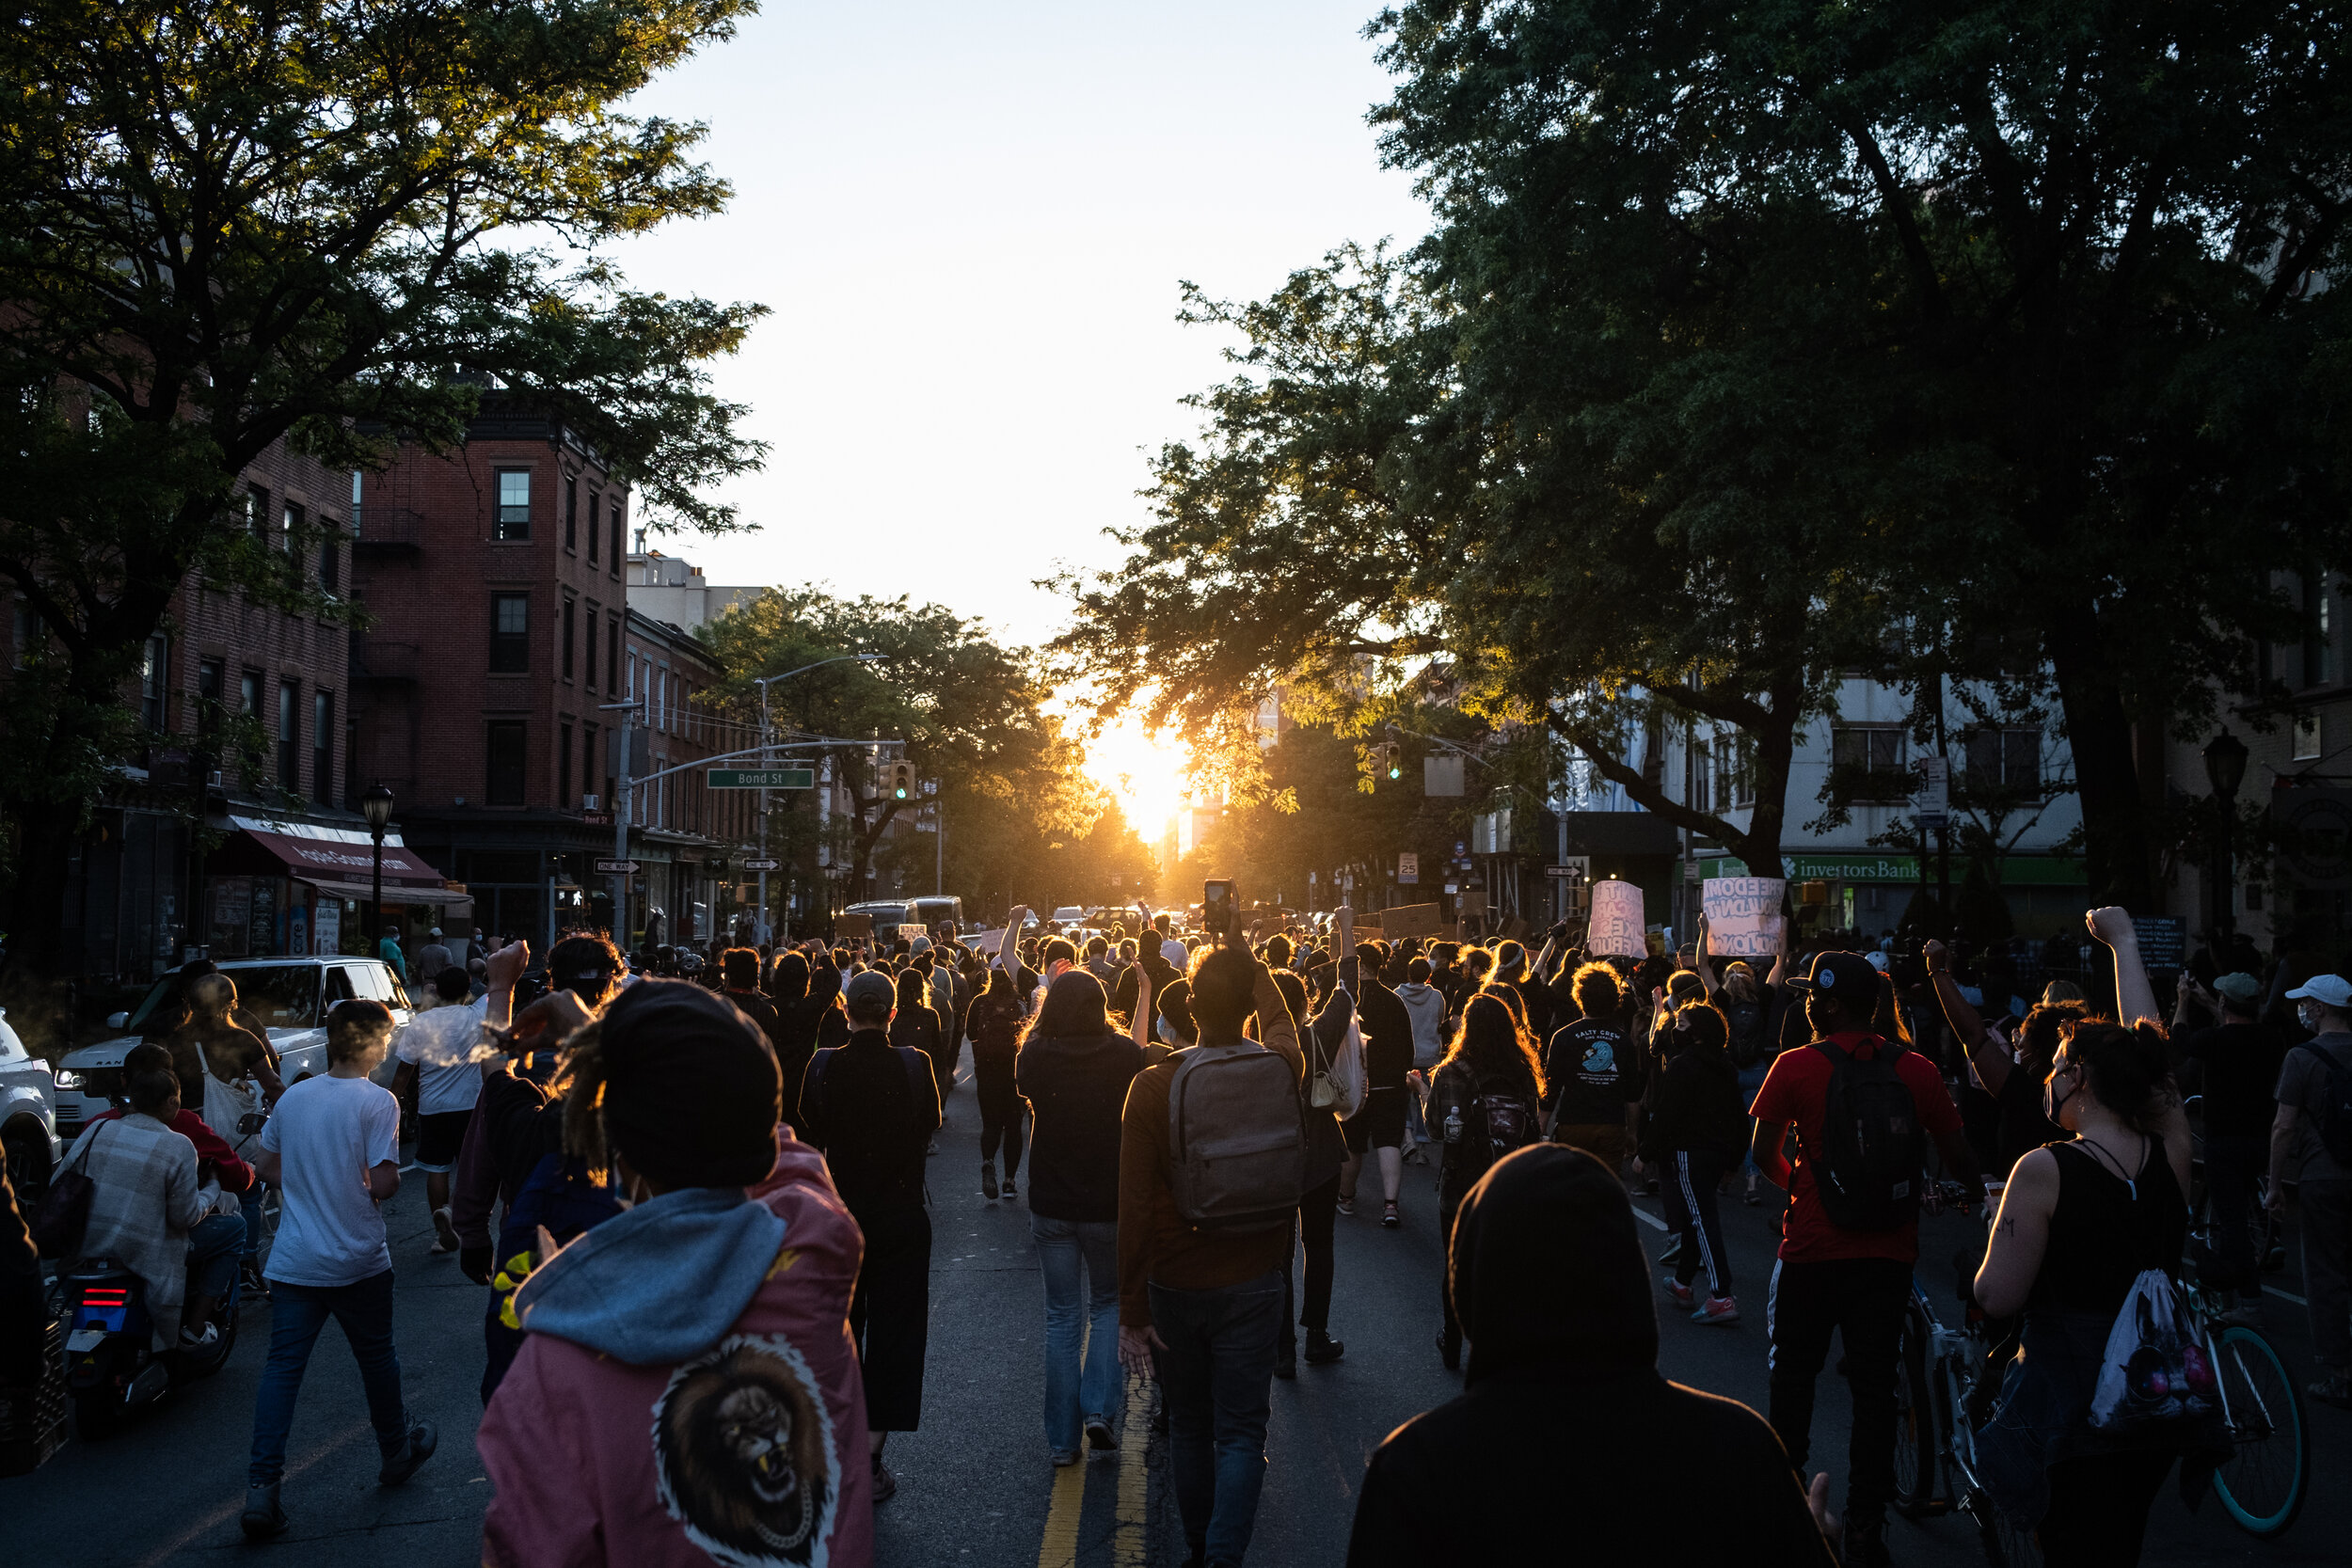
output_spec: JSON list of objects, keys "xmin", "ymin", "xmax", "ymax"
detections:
[{"xmin": 1447, "ymin": 1143, "xmax": 1659, "ymax": 1383}]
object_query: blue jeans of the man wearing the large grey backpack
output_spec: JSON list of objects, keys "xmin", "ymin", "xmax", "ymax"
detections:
[{"xmin": 1151, "ymin": 1272, "xmax": 1282, "ymax": 1563}]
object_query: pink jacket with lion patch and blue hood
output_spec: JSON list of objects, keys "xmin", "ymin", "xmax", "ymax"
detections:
[{"xmin": 475, "ymin": 1135, "xmax": 873, "ymax": 1568}]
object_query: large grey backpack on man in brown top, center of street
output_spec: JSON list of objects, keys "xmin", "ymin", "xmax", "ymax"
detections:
[{"xmin": 1169, "ymin": 1046, "xmax": 1308, "ymax": 1234}]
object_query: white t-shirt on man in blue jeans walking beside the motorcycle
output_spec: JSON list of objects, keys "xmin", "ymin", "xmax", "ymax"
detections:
[{"xmin": 262, "ymin": 1077, "xmax": 400, "ymax": 1289}]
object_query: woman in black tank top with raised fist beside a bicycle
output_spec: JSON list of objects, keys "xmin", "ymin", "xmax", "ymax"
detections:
[{"xmin": 1976, "ymin": 1010, "xmax": 2228, "ymax": 1568}]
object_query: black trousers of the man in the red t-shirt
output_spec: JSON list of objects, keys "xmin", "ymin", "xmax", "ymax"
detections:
[{"xmin": 1767, "ymin": 1258, "xmax": 1913, "ymax": 1524}]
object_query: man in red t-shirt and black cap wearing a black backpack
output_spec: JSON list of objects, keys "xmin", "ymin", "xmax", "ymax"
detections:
[{"xmin": 1750, "ymin": 952, "xmax": 1983, "ymax": 1568}]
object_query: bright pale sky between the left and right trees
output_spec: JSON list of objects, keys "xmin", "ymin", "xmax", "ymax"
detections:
[{"xmin": 610, "ymin": 0, "xmax": 1428, "ymax": 644}]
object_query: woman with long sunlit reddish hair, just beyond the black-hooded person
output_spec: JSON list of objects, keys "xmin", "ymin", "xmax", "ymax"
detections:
[{"xmin": 1414, "ymin": 997, "xmax": 1543, "ymax": 1373}]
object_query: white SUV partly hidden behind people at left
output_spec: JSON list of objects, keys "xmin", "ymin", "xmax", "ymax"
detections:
[{"xmin": 56, "ymin": 957, "xmax": 414, "ymax": 1143}]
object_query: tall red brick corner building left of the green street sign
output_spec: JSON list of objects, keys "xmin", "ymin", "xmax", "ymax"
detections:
[{"xmin": 351, "ymin": 392, "xmax": 751, "ymax": 947}]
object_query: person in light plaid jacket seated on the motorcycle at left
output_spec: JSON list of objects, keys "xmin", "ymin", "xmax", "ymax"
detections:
[{"xmin": 59, "ymin": 1044, "xmax": 254, "ymax": 1350}]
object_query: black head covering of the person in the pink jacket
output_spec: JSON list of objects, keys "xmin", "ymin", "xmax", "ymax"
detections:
[{"xmin": 597, "ymin": 980, "xmax": 784, "ymax": 1187}]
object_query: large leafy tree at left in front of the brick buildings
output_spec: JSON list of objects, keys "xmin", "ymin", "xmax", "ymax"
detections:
[{"xmin": 0, "ymin": 0, "xmax": 762, "ymax": 966}]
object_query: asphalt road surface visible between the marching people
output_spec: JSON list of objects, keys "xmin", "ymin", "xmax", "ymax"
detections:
[{"xmin": 0, "ymin": 1053, "xmax": 2352, "ymax": 1568}]
